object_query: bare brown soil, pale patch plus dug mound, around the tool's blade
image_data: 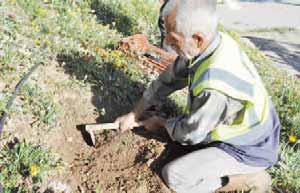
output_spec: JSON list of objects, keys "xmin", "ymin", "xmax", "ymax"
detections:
[{"xmin": 6, "ymin": 59, "xmax": 182, "ymax": 193}]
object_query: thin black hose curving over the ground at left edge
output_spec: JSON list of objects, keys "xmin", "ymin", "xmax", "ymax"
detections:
[{"xmin": 0, "ymin": 63, "xmax": 42, "ymax": 136}]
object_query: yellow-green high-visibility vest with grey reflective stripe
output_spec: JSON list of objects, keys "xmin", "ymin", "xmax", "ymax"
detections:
[{"xmin": 189, "ymin": 34, "xmax": 269, "ymax": 141}]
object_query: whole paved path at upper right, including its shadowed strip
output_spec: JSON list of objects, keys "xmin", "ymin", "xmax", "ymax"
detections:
[{"xmin": 218, "ymin": 2, "xmax": 300, "ymax": 75}]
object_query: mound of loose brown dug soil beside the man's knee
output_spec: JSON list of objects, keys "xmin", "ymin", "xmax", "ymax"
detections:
[{"xmin": 72, "ymin": 129, "xmax": 170, "ymax": 193}]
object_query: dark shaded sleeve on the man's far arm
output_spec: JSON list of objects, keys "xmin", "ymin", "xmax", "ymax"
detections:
[{"xmin": 143, "ymin": 57, "xmax": 188, "ymax": 104}]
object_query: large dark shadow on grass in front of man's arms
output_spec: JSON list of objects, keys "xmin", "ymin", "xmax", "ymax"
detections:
[{"xmin": 57, "ymin": 53, "xmax": 145, "ymax": 123}]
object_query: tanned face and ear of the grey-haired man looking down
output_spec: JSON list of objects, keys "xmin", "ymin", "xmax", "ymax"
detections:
[{"xmin": 164, "ymin": 9, "xmax": 204, "ymax": 59}]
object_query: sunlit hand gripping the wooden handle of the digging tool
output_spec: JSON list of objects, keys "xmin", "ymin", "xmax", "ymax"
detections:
[{"xmin": 115, "ymin": 112, "xmax": 140, "ymax": 132}]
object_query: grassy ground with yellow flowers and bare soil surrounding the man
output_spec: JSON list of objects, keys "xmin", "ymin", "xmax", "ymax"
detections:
[{"xmin": 0, "ymin": 0, "xmax": 300, "ymax": 193}]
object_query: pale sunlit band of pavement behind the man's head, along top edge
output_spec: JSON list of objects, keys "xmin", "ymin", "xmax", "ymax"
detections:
[{"xmin": 218, "ymin": 2, "xmax": 300, "ymax": 30}]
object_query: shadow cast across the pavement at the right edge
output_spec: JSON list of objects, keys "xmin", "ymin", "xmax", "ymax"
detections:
[{"xmin": 245, "ymin": 36, "xmax": 300, "ymax": 73}]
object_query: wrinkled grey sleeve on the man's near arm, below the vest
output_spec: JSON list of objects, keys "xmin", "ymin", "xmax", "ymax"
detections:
[{"xmin": 165, "ymin": 90, "xmax": 243, "ymax": 145}]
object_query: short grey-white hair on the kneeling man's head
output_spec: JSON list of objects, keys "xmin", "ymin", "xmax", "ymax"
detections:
[{"xmin": 161, "ymin": 0, "xmax": 218, "ymax": 40}]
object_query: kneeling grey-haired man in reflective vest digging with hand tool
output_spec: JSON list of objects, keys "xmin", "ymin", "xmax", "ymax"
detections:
[{"xmin": 116, "ymin": 0, "xmax": 280, "ymax": 193}]
